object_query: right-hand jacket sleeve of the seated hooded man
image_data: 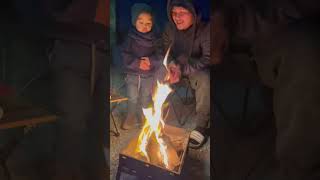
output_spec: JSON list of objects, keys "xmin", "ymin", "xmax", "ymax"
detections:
[{"xmin": 181, "ymin": 24, "xmax": 210, "ymax": 75}]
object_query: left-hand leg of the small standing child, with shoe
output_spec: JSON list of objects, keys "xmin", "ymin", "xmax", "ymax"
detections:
[{"xmin": 121, "ymin": 74, "xmax": 139, "ymax": 129}]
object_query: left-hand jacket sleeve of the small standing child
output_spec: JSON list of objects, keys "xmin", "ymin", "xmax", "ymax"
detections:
[{"xmin": 121, "ymin": 38, "xmax": 140, "ymax": 71}]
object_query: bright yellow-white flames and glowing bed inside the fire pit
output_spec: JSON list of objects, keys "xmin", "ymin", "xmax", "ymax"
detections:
[{"xmin": 123, "ymin": 47, "xmax": 183, "ymax": 170}]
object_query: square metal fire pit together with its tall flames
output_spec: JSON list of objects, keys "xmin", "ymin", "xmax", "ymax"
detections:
[{"xmin": 117, "ymin": 47, "xmax": 189, "ymax": 180}]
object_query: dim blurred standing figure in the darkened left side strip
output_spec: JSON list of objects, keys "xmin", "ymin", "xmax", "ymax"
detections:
[{"xmin": 52, "ymin": 0, "xmax": 108, "ymax": 180}]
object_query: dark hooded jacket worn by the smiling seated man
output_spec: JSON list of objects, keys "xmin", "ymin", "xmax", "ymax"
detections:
[{"xmin": 162, "ymin": 0, "xmax": 210, "ymax": 75}]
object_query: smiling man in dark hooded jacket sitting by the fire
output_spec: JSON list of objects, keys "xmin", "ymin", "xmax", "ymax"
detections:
[{"xmin": 163, "ymin": 0, "xmax": 210, "ymax": 148}]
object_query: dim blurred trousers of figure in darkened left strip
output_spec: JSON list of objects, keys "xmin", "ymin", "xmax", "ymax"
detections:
[{"xmin": 52, "ymin": 41, "xmax": 107, "ymax": 180}]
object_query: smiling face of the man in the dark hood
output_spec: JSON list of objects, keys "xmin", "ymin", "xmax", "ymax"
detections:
[{"xmin": 171, "ymin": 6, "xmax": 193, "ymax": 30}]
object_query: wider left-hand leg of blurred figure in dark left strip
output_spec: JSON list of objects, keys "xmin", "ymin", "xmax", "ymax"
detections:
[{"xmin": 53, "ymin": 42, "xmax": 92, "ymax": 180}]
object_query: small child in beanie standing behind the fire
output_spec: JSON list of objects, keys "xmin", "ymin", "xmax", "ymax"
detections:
[{"xmin": 121, "ymin": 3, "xmax": 160, "ymax": 129}]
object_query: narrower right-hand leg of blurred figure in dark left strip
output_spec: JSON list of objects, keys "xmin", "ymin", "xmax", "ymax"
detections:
[{"xmin": 83, "ymin": 49, "xmax": 109, "ymax": 180}]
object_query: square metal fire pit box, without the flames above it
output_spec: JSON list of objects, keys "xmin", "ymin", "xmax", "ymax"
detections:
[{"xmin": 116, "ymin": 125, "xmax": 189, "ymax": 180}]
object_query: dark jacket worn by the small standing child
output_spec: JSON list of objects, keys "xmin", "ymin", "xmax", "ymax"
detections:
[{"xmin": 121, "ymin": 28, "xmax": 161, "ymax": 76}]
